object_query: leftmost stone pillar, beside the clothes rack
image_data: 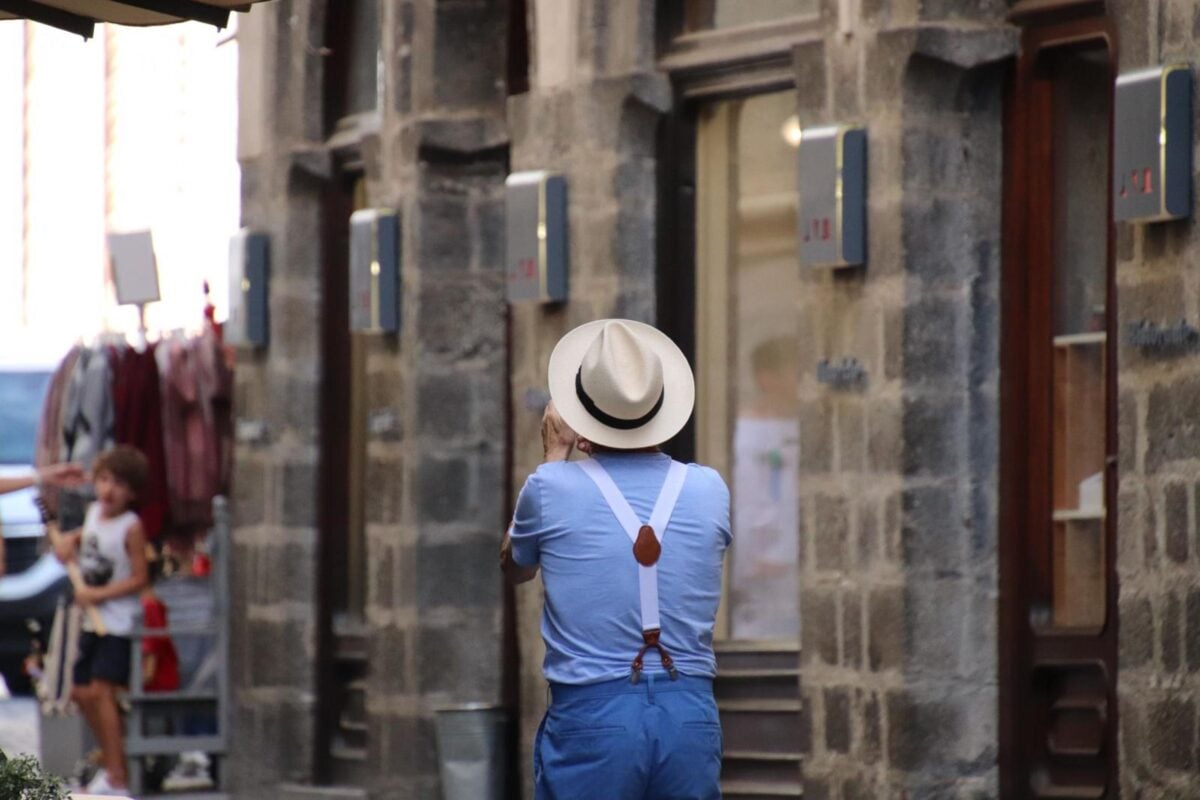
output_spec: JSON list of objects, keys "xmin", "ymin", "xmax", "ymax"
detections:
[{"xmin": 226, "ymin": 0, "xmax": 320, "ymax": 798}]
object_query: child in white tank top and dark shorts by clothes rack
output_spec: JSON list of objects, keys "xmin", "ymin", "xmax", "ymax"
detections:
[{"xmin": 58, "ymin": 445, "xmax": 149, "ymax": 794}]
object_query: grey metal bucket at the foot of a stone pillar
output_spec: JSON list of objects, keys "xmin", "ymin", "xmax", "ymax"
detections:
[{"xmin": 436, "ymin": 703, "xmax": 509, "ymax": 800}]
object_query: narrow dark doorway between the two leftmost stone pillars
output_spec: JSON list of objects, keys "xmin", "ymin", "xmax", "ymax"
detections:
[{"xmin": 313, "ymin": 0, "xmax": 382, "ymax": 787}]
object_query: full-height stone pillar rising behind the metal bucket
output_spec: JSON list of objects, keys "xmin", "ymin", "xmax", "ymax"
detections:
[{"xmin": 355, "ymin": 0, "xmax": 508, "ymax": 799}]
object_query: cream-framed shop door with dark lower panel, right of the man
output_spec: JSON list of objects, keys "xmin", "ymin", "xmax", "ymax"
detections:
[{"xmin": 678, "ymin": 89, "xmax": 802, "ymax": 798}]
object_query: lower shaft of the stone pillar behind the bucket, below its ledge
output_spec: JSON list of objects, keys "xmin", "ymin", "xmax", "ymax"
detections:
[{"xmin": 366, "ymin": 148, "xmax": 506, "ymax": 798}]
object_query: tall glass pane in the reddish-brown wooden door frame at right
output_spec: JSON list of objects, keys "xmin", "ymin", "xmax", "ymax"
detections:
[{"xmin": 1049, "ymin": 48, "xmax": 1112, "ymax": 628}]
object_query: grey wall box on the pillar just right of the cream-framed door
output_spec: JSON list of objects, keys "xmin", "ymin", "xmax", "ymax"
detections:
[{"xmin": 797, "ymin": 125, "xmax": 866, "ymax": 266}]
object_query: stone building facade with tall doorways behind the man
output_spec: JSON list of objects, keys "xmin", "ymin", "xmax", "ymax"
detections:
[{"xmin": 229, "ymin": 0, "xmax": 1200, "ymax": 800}]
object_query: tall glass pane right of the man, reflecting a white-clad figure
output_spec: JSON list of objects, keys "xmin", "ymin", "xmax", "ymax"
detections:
[{"xmin": 696, "ymin": 91, "xmax": 800, "ymax": 639}]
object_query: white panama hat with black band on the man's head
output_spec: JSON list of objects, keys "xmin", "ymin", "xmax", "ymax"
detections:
[{"xmin": 548, "ymin": 319, "xmax": 696, "ymax": 450}]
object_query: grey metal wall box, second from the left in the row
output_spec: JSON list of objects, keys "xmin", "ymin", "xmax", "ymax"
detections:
[{"xmin": 350, "ymin": 209, "xmax": 401, "ymax": 333}]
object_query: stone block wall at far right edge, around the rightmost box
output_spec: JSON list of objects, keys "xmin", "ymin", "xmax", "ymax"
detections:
[{"xmin": 1116, "ymin": 0, "xmax": 1200, "ymax": 799}]
